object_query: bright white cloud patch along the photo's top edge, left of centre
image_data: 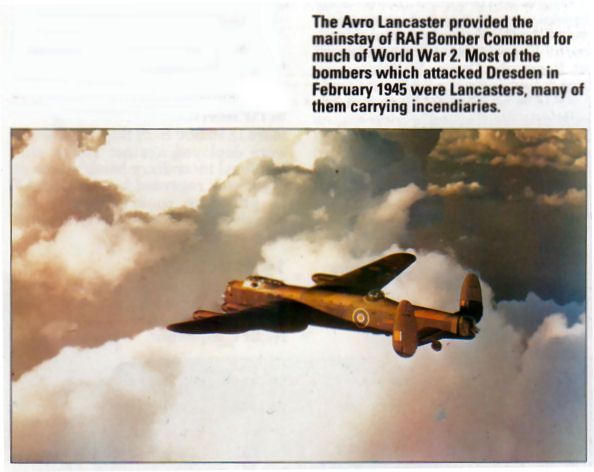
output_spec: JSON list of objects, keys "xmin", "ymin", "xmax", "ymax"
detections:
[{"xmin": 76, "ymin": 130, "xmax": 302, "ymax": 213}]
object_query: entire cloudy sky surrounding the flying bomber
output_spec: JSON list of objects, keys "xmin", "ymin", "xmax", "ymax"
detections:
[{"xmin": 11, "ymin": 130, "xmax": 586, "ymax": 462}]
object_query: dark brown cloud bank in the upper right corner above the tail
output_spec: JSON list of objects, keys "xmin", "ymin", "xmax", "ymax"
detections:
[{"xmin": 404, "ymin": 130, "xmax": 586, "ymax": 304}]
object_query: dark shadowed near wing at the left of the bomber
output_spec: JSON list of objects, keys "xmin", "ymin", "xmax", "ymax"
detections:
[{"xmin": 167, "ymin": 302, "xmax": 308, "ymax": 334}]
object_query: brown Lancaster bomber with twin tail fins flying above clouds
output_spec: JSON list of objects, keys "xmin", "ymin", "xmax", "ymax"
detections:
[{"xmin": 167, "ymin": 253, "xmax": 483, "ymax": 357}]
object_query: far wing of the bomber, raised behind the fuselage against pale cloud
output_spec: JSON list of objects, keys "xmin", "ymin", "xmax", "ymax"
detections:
[{"xmin": 313, "ymin": 252, "xmax": 416, "ymax": 295}]
